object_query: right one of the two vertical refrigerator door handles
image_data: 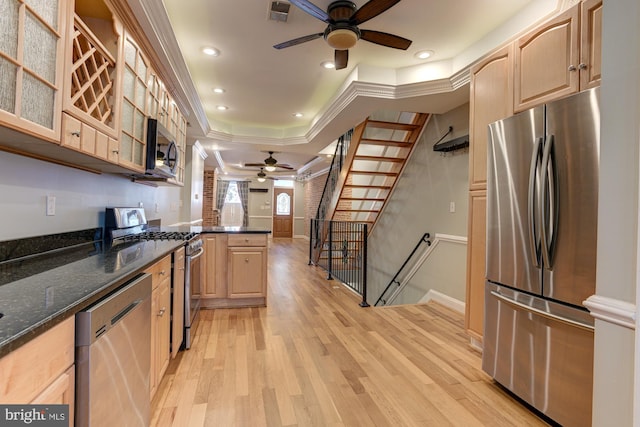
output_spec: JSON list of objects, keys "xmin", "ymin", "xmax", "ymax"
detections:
[{"xmin": 540, "ymin": 135, "xmax": 559, "ymax": 270}]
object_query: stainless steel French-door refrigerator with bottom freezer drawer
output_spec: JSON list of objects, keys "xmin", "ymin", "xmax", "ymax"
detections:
[{"xmin": 482, "ymin": 88, "xmax": 600, "ymax": 426}]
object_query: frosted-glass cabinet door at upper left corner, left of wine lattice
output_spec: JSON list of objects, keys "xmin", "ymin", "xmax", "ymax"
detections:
[{"xmin": 0, "ymin": 0, "xmax": 68, "ymax": 143}]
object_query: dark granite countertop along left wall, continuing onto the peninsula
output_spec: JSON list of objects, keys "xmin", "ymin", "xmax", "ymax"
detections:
[{"xmin": 0, "ymin": 226, "xmax": 271, "ymax": 357}]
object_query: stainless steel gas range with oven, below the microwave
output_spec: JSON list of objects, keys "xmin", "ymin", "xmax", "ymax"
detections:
[{"xmin": 105, "ymin": 208, "xmax": 204, "ymax": 349}]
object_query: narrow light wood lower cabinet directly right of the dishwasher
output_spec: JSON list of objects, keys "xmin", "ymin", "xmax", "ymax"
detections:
[{"xmin": 147, "ymin": 255, "xmax": 171, "ymax": 398}]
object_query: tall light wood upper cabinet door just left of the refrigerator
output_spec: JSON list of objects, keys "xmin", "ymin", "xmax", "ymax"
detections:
[{"xmin": 469, "ymin": 44, "xmax": 513, "ymax": 190}]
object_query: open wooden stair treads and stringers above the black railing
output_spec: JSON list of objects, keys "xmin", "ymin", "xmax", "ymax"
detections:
[{"xmin": 326, "ymin": 112, "xmax": 429, "ymax": 232}]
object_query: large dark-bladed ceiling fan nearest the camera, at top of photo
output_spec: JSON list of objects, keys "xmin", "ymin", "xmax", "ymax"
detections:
[{"xmin": 273, "ymin": 0, "xmax": 411, "ymax": 70}]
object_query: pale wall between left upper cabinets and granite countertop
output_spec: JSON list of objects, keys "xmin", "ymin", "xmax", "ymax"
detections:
[{"xmin": 0, "ymin": 151, "xmax": 188, "ymax": 240}]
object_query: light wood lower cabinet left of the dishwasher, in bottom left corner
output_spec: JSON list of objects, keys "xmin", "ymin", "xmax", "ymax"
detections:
[{"xmin": 0, "ymin": 316, "xmax": 75, "ymax": 418}]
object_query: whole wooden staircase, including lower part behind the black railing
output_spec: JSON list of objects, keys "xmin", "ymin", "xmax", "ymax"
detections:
[{"xmin": 309, "ymin": 112, "xmax": 429, "ymax": 270}]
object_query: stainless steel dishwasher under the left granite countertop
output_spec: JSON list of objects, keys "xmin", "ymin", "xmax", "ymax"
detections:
[{"xmin": 75, "ymin": 274, "xmax": 151, "ymax": 427}]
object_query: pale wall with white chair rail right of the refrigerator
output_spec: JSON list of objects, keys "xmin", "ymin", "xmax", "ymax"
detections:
[{"xmin": 589, "ymin": 0, "xmax": 640, "ymax": 427}]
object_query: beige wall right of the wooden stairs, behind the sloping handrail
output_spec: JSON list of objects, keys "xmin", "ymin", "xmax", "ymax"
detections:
[{"xmin": 367, "ymin": 104, "xmax": 469, "ymax": 304}]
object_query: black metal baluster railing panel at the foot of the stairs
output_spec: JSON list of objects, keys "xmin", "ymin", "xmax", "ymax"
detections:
[{"xmin": 309, "ymin": 219, "xmax": 369, "ymax": 307}]
